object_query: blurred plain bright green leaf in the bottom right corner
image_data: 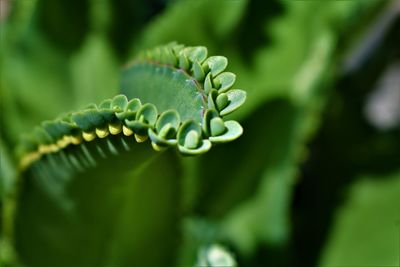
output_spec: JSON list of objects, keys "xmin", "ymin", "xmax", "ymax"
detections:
[{"xmin": 319, "ymin": 172, "xmax": 400, "ymax": 267}]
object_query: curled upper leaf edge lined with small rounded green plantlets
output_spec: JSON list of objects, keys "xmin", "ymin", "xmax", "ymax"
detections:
[{"xmin": 18, "ymin": 43, "xmax": 246, "ymax": 172}]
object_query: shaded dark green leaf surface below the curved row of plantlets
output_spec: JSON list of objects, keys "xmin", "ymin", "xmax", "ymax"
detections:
[{"xmin": 15, "ymin": 140, "xmax": 180, "ymax": 267}]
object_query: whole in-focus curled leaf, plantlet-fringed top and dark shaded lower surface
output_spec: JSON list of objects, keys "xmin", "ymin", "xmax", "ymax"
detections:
[{"xmin": 10, "ymin": 40, "xmax": 244, "ymax": 266}]
